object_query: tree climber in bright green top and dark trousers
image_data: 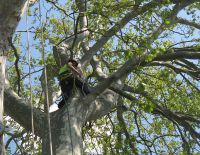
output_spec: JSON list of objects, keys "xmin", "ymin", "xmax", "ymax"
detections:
[{"xmin": 58, "ymin": 59, "xmax": 90, "ymax": 108}]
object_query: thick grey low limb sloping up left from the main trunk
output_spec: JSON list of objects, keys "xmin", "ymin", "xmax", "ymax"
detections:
[{"xmin": 4, "ymin": 83, "xmax": 47, "ymax": 137}]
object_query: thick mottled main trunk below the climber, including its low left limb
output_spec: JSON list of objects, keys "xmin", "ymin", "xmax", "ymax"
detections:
[{"xmin": 4, "ymin": 78, "xmax": 116, "ymax": 155}]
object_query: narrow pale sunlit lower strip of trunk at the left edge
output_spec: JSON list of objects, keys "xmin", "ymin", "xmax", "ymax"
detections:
[{"xmin": 0, "ymin": 57, "xmax": 6, "ymax": 155}]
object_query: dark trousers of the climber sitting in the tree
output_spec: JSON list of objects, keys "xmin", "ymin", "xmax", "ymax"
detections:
[{"xmin": 58, "ymin": 77, "xmax": 90, "ymax": 108}]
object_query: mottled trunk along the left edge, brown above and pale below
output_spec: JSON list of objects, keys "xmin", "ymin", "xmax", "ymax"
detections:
[{"xmin": 0, "ymin": 0, "xmax": 26, "ymax": 155}]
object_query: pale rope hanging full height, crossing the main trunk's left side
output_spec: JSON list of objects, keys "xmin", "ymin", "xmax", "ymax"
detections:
[{"xmin": 39, "ymin": 0, "xmax": 53, "ymax": 155}]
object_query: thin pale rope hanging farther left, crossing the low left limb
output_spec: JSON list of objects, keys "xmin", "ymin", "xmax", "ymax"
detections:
[{"xmin": 26, "ymin": 0, "xmax": 35, "ymax": 153}]
